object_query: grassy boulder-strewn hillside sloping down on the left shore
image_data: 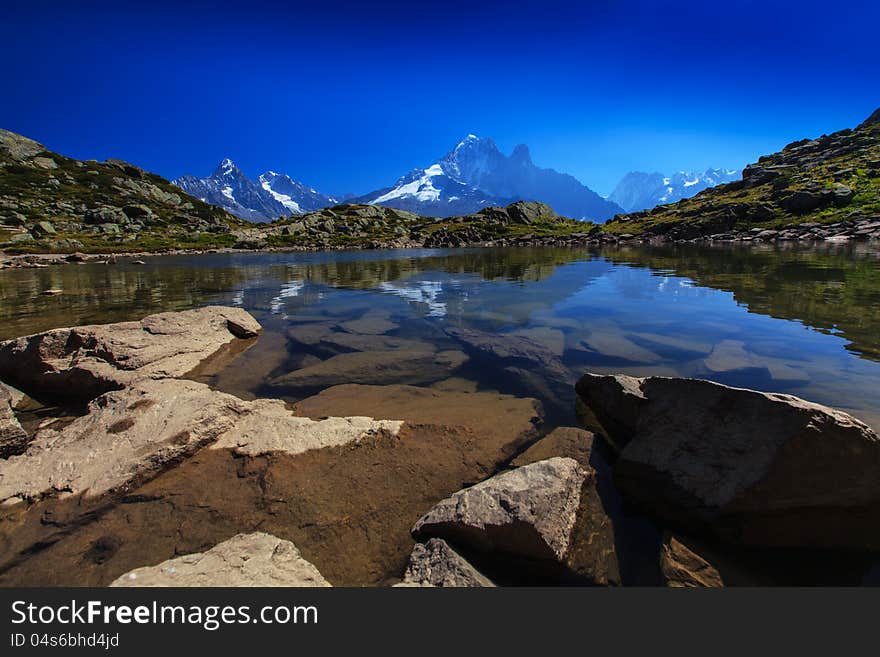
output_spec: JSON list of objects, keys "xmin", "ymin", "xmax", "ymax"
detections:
[{"xmin": 0, "ymin": 130, "xmax": 245, "ymax": 252}]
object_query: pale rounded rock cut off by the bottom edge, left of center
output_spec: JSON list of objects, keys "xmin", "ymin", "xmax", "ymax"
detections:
[{"xmin": 110, "ymin": 532, "xmax": 330, "ymax": 587}]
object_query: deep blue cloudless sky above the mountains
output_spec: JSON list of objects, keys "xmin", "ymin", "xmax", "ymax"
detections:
[{"xmin": 0, "ymin": 0, "xmax": 880, "ymax": 194}]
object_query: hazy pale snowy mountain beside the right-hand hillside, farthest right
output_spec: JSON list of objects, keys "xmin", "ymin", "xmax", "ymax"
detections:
[{"xmin": 608, "ymin": 169, "xmax": 742, "ymax": 212}]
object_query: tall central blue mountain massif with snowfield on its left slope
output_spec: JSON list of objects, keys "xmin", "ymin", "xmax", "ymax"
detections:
[{"xmin": 352, "ymin": 135, "xmax": 621, "ymax": 221}]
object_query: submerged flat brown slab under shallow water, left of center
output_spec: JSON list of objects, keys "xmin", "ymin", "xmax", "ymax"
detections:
[{"xmin": 270, "ymin": 349, "xmax": 468, "ymax": 389}]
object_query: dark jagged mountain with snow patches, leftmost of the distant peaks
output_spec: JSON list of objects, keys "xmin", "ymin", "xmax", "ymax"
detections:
[{"xmin": 172, "ymin": 158, "xmax": 336, "ymax": 222}]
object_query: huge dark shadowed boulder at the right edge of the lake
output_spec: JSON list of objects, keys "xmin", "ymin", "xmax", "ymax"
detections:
[{"xmin": 577, "ymin": 374, "xmax": 880, "ymax": 549}]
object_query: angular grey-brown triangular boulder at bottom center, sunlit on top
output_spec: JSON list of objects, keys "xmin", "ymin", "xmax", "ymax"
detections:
[{"xmin": 413, "ymin": 457, "xmax": 587, "ymax": 561}]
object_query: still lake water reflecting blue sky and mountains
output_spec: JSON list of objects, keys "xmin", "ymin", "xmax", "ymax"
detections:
[{"xmin": 0, "ymin": 245, "xmax": 880, "ymax": 428}]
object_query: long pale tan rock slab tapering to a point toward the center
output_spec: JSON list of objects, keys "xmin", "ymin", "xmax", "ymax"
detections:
[{"xmin": 0, "ymin": 379, "xmax": 401, "ymax": 502}]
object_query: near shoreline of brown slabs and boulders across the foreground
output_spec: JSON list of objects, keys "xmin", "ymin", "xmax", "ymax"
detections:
[{"xmin": 0, "ymin": 307, "xmax": 880, "ymax": 587}]
